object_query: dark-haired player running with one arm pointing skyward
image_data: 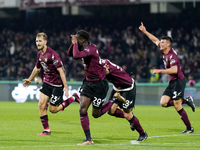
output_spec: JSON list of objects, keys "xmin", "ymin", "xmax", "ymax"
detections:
[{"xmin": 139, "ymin": 22, "xmax": 195, "ymax": 133}]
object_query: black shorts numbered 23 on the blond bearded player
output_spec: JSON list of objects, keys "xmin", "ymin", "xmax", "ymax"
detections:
[{"xmin": 40, "ymin": 82, "xmax": 63, "ymax": 106}]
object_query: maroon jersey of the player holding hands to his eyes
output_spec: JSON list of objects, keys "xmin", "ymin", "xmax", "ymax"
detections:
[{"xmin": 68, "ymin": 44, "xmax": 106, "ymax": 81}]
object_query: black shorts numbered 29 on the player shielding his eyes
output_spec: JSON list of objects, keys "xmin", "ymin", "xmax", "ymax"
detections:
[{"xmin": 80, "ymin": 79, "xmax": 109, "ymax": 109}]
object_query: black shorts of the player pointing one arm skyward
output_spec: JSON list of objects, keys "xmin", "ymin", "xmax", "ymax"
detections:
[{"xmin": 163, "ymin": 78, "xmax": 186, "ymax": 100}]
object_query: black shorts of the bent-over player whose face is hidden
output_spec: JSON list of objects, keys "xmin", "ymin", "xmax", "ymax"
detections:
[{"xmin": 109, "ymin": 83, "xmax": 136, "ymax": 110}]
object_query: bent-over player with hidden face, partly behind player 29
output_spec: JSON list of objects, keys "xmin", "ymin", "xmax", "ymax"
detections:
[{"xmin": 101, "ymin": 59, "xmax": 148, "ymax": 141}]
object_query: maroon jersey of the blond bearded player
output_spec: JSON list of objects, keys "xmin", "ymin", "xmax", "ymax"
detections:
[{"xmin": 35, "ymin": 47, "xmax": 63, "ymax": 86}]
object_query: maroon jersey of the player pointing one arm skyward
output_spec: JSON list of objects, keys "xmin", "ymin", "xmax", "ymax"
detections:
[{"xmin": 163, "ymin": 48, "xmax": 185, "ymax": 81}]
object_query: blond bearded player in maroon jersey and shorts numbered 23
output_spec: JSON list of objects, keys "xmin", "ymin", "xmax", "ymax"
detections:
[{"xmin": 23, "ymin": 32, "xmax": 79, "ymax": 135}]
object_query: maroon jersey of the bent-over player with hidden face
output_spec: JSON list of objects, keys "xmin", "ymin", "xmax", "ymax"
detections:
[{"xmin": 101, "ymin": 59, "xmax": 133, "ymax": 90}]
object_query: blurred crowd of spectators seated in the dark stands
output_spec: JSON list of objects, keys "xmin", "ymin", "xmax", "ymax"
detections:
[{"xmin": 0, "ymin": 8, "xmax": 200, "ymax": 83}]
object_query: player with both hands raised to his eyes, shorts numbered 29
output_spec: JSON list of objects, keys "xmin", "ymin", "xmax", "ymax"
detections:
[{"xmin": 68, "ymin": 30, "xmax": 126, "ymax": 145}]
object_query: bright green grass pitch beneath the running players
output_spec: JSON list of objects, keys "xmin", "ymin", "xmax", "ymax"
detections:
[{"xmin": 0, "ymin": 102, "xmax": 200, "ymax": 150}]
